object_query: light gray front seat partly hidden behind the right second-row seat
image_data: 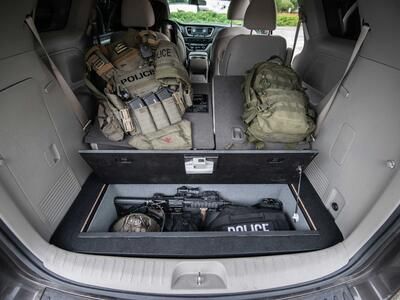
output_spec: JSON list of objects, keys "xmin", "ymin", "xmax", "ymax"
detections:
[{"xmin": 211, "ymin": 0, "xmax": 250, "ymax": 75}]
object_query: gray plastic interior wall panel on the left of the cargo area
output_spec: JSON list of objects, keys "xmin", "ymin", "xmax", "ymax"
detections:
[{"xmin": 0, "ymin": 0, "xmax": 91, "ymax": 239}]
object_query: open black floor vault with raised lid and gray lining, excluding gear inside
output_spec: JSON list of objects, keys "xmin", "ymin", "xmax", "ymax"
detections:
[{"xmin": 52, "ymin": 150, "xmax": 342, "ymax": 257}]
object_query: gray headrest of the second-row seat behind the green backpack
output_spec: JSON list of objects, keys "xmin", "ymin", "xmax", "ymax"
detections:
[{"xmin": 243, "ymin": 0, "xmax": 276, "ymax": 30}]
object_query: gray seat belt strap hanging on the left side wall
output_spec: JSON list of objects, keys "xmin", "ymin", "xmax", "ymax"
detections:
[{"xmin": 25, "ymin": 16, "xmax": 91, "ymax": 131}]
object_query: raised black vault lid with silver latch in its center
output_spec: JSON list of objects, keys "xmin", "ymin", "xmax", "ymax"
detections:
[{"xmin": 80, "ymin": 150, "xmax": 318, "ymax": 184}]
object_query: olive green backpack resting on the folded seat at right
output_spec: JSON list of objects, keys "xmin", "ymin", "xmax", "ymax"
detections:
[{"xmin": 242, "ymin": 58, "xmax": 315, "ymax": 148}]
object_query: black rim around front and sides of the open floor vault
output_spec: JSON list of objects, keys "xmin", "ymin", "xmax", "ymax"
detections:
[{"xmin": 50, "ymin": 176, "xmax": 343, "ymax": 258}]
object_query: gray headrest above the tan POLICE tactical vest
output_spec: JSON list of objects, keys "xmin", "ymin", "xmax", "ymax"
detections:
[{"xmin": 121, "ymin": 0, "xmax": 155, "ymax": 28}]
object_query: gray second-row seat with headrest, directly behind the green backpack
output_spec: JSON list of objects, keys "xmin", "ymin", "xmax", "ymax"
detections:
[{"xmin": 220, "ymin": 0, "xmax": 287, "ymax": 76}]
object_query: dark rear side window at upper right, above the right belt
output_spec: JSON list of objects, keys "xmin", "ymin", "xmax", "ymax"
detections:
[{"xmin": 323, "ymin": 0, "xmax": 361, "ymax": 40}]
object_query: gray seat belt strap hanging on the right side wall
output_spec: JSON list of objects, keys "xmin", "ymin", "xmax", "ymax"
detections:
[{"xmin": 314, "ymin": 25, "xmax": 370, "ymax": 138}]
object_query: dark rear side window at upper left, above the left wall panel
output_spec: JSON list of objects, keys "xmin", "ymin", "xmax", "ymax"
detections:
[{"xmin": 35, "ymin": 0, "xmax": 71, "ymax": 32}]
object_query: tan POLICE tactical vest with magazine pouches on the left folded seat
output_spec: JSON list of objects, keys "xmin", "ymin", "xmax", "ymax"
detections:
[{"xmin": 86, "ymin": 31, "xmax": 192, "ymax": 149}]
